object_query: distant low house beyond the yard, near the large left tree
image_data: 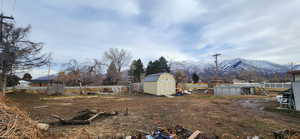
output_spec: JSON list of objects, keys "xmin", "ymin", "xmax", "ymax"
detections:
[{"xmin": 30, "ymin": 75, "xmax": 56, "ymax": 87}]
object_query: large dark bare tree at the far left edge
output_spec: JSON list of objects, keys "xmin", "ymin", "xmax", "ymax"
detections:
[{"xmin": 0, "ymin": 24, "xmax": 50, "ymax": 96}]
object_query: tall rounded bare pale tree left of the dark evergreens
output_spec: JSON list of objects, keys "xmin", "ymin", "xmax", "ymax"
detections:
[{"xmin": 104, "ymin": 48, "xmax": 131, "ymax": 72}]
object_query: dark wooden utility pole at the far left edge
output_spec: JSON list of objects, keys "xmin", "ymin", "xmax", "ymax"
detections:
[{"xmin": 0, "ymin": 13, "xmax": 14, "ymax": 96}]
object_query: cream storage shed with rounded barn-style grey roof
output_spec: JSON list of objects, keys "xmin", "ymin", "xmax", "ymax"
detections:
[{"xmin": 144, "ymin": 73, "xmax": 176, "ymax": 96}]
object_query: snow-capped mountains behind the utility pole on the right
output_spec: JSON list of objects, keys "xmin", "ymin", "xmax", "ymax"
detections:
[{"xmin": 171, "ymin": 58, "xmax": 289, "ymax": 72}]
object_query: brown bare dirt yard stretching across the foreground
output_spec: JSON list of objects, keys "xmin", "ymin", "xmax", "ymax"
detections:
[{"xmin": 4, "ymin": 93, "xmax": 300, "ymax": 138}]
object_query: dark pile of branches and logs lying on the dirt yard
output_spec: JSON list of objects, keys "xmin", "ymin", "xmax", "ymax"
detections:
[{"xmin": 51, "ymin": 109, "xmax": 118, "ymax": 125}]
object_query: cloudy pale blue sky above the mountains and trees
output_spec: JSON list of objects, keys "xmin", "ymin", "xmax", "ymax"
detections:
[{"xmin": 1, "ymin": 0, "xmax": 300, "ymax": 77}]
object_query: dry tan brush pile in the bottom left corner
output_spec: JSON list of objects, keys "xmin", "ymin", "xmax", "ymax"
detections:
[{"xmin": 0, "ymin": 98, "xmax": 40, "ymax": 139}]
